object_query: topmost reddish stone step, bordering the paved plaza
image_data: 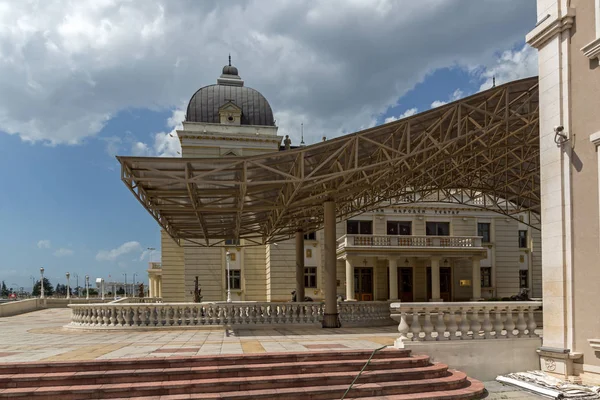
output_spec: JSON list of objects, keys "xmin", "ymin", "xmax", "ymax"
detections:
[{"xmin": 0, "ymin": 348, "xmax": 410, "ymax": 375}]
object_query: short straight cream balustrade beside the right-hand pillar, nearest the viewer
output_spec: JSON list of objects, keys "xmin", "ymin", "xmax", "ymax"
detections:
[{"xmin": 391, "ymin": 301, "xmax": 542, "ymax": 344}]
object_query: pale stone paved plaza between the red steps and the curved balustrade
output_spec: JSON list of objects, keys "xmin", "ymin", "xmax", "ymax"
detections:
[{"xmin": 0, "ymin": 309, "xmax": 398, "ymax": 363}]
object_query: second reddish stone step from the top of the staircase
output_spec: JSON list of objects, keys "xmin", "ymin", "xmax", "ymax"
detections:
[{"xmin": 0, "ymin": 355, "xmax": 429, "ymax": 388}]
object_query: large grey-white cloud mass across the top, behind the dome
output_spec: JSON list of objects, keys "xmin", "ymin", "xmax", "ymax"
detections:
[{"xmin": 0, "ymin": 0, "xmax": 536, "ymax": 147}]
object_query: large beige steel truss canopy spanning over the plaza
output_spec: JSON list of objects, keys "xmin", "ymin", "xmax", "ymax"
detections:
[{"xmin": 117, "ymin": 77, "xmax": 540, "ymax": 246}]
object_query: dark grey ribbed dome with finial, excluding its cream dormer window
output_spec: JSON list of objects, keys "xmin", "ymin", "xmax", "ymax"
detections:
[{"xmin": 185, "ymin": 65, "xmax": 275, "ymax": 126}]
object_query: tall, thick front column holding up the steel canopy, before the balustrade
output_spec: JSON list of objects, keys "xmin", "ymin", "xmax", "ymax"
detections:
[{"xmin": 323, "ymin": 201, "xmax": 339, "ymax": 328}]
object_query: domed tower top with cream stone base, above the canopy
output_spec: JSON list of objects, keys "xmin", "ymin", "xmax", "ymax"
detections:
[{"xmin": 177, "ymin": 58, "xmax": 283, "ymax": 158}]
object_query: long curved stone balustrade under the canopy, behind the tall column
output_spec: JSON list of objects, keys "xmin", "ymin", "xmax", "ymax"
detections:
[{"xmin": 69, "ymin": 298, "xmax": 394, "ymax": 328}]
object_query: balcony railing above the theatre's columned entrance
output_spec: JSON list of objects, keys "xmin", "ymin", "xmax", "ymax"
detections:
[{"xmin": 338, "ymin": 235, "xmax": 482, "ymax": 250}]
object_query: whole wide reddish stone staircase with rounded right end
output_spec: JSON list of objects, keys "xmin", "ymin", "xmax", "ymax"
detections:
[{"xmin": 0, "ymin": 348, "xmax": 485, "ymax": 400}]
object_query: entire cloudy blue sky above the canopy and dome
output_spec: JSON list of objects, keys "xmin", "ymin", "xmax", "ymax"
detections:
[{"xmin": 0, "ymin": 0, "xmax": 537, "ymax": 289}]
